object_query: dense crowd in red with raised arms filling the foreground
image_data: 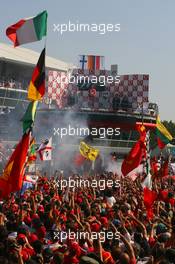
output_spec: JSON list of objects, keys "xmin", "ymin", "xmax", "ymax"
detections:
[{"xmin": 0, "ymin": 172, "xmax": 175, "ymax": 264}]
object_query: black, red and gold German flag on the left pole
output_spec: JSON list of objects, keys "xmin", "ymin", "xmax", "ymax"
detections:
[{"xmin": 28, "ymin": 48, "xmax": 45, "ymax": 101}]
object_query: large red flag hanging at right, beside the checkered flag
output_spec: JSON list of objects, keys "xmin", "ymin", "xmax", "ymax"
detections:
[{"xmin": 121, "ymin": 126, "xmax": 146, "ymax": 176}]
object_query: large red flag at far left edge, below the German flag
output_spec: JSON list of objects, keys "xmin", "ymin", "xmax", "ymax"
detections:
[{"xmin": 0, "ymin": 133, "xmax": 30, "ymax": 198}]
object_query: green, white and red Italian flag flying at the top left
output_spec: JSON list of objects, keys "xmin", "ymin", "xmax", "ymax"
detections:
[{"xmin": 6, "ymin": 11, "xmax": 47, "ymax": 47}]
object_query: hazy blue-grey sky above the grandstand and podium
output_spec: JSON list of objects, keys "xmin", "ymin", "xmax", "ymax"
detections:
[{"xmin": 0, "ymin": 0, "xmax": 175, "ymax": 121}]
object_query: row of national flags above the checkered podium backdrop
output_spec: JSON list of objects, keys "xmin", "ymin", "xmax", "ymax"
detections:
[{"xmin": 79, "ymin": 55, "xmax": 105, "ymax": 70}]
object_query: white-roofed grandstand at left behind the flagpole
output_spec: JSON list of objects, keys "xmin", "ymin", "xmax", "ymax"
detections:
[{"xmin": 0, "ymin": 43, "xmax": 73, "ymax": 139}]
